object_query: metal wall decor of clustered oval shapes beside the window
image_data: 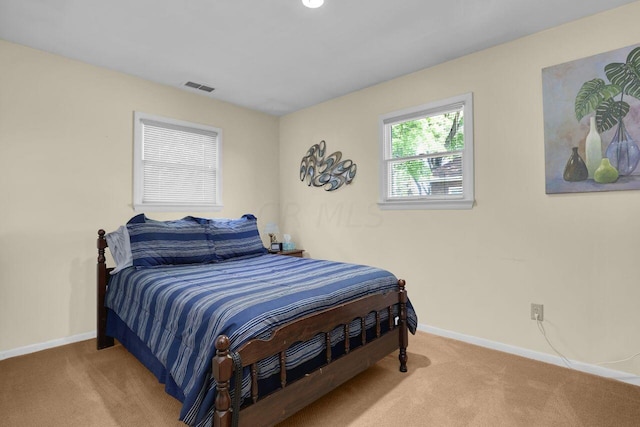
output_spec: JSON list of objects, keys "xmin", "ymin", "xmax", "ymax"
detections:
[{"xmin": 300, "ymin": 140, "xmax": 357, "ymax": 191}]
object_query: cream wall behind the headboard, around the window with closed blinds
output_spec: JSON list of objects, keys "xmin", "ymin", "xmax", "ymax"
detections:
[{"xmin": 0, "ymin": 40, "xmax": 279, "ymax": 352}]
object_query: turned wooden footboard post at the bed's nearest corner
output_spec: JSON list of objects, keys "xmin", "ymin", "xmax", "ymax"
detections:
[{"xmin": 212, "ymin": 335, "xmax": 234, "ymax": 427}]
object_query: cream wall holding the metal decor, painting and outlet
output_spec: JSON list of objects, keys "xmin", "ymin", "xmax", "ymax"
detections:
[{"xmin": 280, "ymin": 2, "xmax": 640, "ymax": 374}]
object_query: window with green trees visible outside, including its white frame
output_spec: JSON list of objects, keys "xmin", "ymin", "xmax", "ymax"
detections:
[{"xmin": 378, "ymin": 93, "xmax": 474, "ymax": 209}]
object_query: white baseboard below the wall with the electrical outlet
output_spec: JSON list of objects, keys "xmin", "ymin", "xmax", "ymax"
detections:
[{"xmin": 418, "ymin": 324, "xmax": 640, "ymax": 386}]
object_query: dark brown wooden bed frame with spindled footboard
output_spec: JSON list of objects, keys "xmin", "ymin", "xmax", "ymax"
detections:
[{"xmin": 97, "ymin": 230, "xmax": 408, "ymax": 427}]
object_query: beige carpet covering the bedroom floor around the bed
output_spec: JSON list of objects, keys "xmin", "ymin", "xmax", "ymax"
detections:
[{"xmin": 0, "ymin": 333, "xmax": 640, "ymax": 427}]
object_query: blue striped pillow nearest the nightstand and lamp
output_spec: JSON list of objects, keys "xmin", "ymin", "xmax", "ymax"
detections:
[{"xmin": 207, "ymin": 214, "xmax": 268, "ymax": 261}]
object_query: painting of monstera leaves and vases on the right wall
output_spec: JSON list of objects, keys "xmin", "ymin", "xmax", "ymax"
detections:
[{"xmin": 542, "ymin": 46, "xmax": 640, "ymax": 193}]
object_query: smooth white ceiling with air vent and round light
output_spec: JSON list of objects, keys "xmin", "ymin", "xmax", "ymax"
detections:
[{"xmin": 0, "ymin": 0, "xmax": 635, "ymax": 116}]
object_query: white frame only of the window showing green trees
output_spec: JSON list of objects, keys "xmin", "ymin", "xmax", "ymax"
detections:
[{"xmin": 378, "ymin": 92, "xmax": 475, "ymax": 210}]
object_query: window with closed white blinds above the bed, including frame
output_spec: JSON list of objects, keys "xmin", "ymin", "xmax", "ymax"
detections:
[{"xmin": 133, "ymin": 112, "xmax": 222, "ymax": 211}]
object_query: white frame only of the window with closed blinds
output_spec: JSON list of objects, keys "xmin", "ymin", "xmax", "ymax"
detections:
[{"xmin": 133, "ymin": 111, "xmax": 223, "ymax": 212}]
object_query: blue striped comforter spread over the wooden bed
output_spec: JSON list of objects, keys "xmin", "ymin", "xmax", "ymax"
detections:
[{"xmin": 106, "ymin": 255, "xmax": 417, "ymax": 425}]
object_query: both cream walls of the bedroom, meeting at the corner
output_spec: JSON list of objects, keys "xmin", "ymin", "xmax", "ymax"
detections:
[{"xmin": 0, "ymin": 2, "xmax": 640, "ymax": 374}]
